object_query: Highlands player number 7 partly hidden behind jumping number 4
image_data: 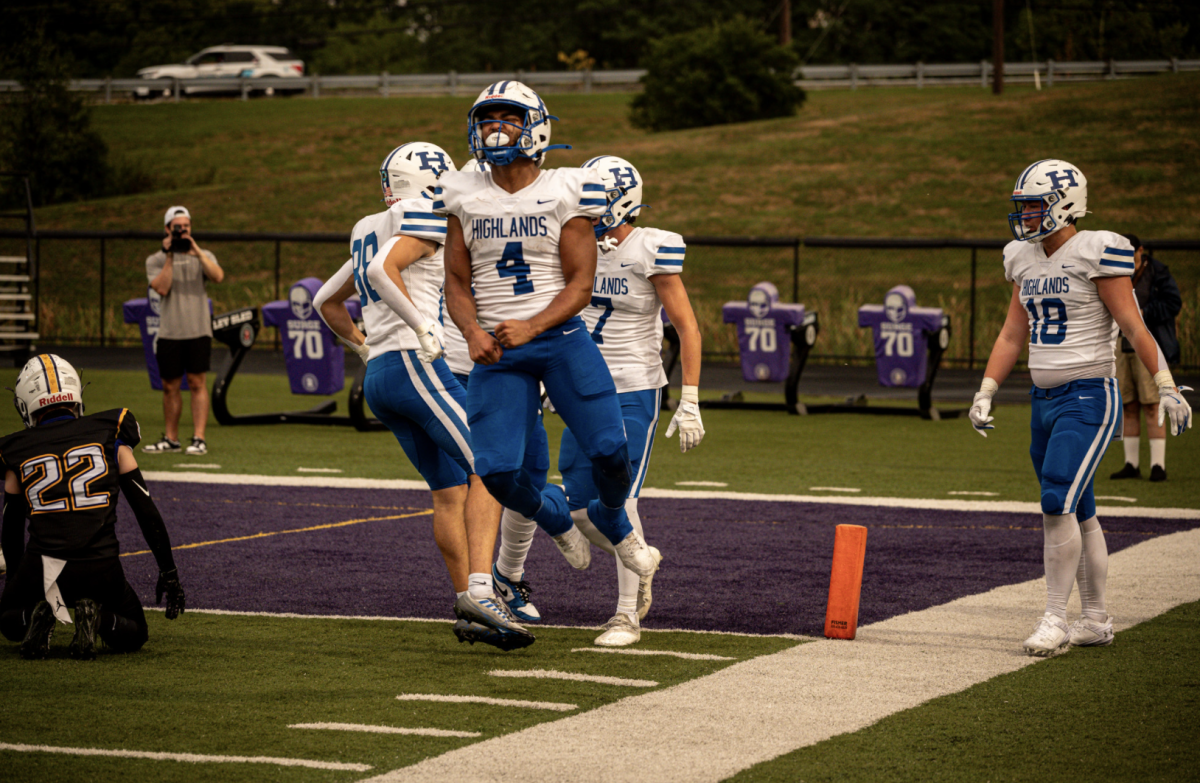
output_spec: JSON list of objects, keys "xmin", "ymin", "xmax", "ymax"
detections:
[{"xmin": 558, "ymin": 155, "xmax": 704, "ymax": 647}]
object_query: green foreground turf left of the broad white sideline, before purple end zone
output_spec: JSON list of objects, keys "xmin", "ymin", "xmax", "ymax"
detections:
[{"xmin": 0, "ymin": 611, "xmax": 797, "ymax": 783}]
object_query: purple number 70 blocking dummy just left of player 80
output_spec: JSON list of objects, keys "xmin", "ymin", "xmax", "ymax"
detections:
[{"xmin": 263, "ymin": 277, "xmax": 360, "ymax": 394}]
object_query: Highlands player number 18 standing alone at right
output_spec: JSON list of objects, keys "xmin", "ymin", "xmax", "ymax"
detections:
[{"xmin": 970, "ymin": 160, "xmax": 1192, "ymax": 656}]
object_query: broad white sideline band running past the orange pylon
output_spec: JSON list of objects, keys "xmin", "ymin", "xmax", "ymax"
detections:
[{"xmin": 370, "ymin": 528, "xmax": 1200, "ymax": 783}]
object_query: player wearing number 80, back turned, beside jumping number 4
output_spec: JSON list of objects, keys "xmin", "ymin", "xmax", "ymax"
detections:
[{"xmin": 313, "ymin": 142, "xmax": 534, "ymax": 650}]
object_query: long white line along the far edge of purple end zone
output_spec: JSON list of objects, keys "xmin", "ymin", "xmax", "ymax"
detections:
[{"xmin": 142, "ymin": 471, "xmax": 1200, "ymax": 516}]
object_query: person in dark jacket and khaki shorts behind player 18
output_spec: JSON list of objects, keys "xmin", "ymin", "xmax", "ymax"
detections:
[{"xmin": 1109, "ymin": 234, "xmax": 1183, "ymax": 482}]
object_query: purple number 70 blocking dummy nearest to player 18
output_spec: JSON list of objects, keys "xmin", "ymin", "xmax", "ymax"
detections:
[{"xmin": 858, "ymin": 286, "xmax": 942, "ymax": 388}]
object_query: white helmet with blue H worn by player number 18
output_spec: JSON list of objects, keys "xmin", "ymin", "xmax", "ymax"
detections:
[{"xmin": 1008, "ymin": 159, "xmax": 1087, "ymax": 243}]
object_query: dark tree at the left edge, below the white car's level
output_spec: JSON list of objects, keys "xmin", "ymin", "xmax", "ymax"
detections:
[{"xmin": 0, "ymin": 25, "xmax": 112, "ymax": 207}]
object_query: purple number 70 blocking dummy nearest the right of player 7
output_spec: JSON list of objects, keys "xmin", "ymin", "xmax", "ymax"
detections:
[{"xmin": 721, "ymin": 282, "xmax": 804, "ymax": 381}]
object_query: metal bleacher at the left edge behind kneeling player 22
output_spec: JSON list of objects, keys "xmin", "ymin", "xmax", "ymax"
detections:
[{"xmin": 0, "ymin": 172, "xmax": 38, "ymax": 367}]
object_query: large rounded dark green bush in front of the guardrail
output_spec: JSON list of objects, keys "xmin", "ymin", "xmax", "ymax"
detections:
[{"xmin": 630, "ymin": 17, "xmax": 805, "ymax": 131}]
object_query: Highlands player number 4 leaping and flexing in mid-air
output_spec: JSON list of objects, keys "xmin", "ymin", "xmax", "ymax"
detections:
[{"xmin": 433, "ymin": 80, "xmax": 658, "ymax": 586}]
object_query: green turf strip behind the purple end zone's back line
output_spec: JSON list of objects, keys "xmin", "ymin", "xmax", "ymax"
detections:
[{"xmin": 0, "ymin": 370, "xmax": 1200, "ymax": 508}]
